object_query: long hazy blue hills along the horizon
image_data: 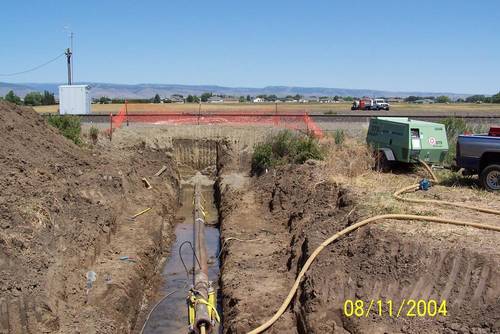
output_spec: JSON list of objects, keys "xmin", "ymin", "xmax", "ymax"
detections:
[{"xmin": 0, "ymin": 82, "xmax": 471, "ymax": 99}]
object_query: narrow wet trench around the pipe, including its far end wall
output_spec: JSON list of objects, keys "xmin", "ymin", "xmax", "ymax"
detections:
[{"xmin": 136, "ymin": 139, "xmax": 222, "ymax": 334}]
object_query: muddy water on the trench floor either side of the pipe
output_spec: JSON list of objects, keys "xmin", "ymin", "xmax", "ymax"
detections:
[{"xmin": 144, "ymin": 174, "xmax": 220, "ymax": 334}]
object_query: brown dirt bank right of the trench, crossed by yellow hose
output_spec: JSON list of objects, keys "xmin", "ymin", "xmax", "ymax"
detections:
[{"xmin": 220, "ymin": 149, "xmax": 500, "ymax": 333}]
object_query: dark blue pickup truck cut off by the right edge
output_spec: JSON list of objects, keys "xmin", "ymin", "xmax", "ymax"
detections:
[{"xmin": 456, "ymin": 128, "xmax": 500, "ymax": 191}]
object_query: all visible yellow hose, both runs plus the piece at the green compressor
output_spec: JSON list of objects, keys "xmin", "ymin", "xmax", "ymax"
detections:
[{"xmin": 248, "ymin": 160, "xmax": 500, "ymax": 334}]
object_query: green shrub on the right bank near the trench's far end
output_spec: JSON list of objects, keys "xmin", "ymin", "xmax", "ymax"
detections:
[{"xmin": 252, "ymin": 130, "xmax": 324, "ymax": 174}]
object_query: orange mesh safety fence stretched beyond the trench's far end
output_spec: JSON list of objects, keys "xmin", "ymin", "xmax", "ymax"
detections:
[{"xmin": 110, "ymin": 105, "xmax": 323, "ymax": 138}]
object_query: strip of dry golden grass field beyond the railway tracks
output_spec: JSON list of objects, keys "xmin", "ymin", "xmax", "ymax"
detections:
[{"xmin": 34, "ymin": 102, "xmax": 500, "ymax": 115}]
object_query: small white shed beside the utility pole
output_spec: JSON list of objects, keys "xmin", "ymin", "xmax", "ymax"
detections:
[{"xmin": 59, "ymin": 85, "xmax": 91, "ymax": 115}]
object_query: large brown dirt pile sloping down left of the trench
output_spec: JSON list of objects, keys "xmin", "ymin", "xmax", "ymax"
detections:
[{"xmin": 0, "ymin": 102, "xmax": 179, "ymax": 333}]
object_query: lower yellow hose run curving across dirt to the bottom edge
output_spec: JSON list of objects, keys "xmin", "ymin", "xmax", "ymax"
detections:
[{"xmin": 248, "ymin": 214, "xmax": 500, "ymax": 334}]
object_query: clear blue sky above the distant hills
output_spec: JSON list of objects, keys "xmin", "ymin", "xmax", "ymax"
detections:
[{"xmin": 0, "ymin": 0, "xmax": 500, "ymax": 94}]
